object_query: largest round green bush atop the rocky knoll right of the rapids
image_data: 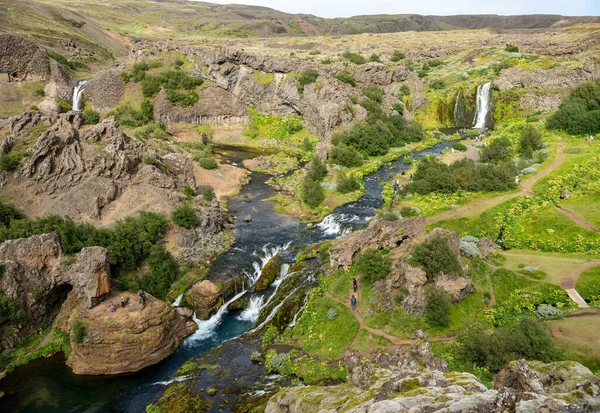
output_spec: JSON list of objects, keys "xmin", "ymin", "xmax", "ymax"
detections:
[{"xmin": 412, "ymin": 236, "xmax": 462, "ymax": 279}]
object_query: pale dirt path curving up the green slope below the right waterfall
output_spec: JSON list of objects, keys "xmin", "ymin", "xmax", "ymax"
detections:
[{"xmin": 426, "ymin": 142, "xmax": 566, "ymax": 224}]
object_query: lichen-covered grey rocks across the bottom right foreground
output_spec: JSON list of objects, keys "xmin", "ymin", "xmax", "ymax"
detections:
[{"xmin": 265, "ymin": 331, "xmax": 600, "ymax": 413}]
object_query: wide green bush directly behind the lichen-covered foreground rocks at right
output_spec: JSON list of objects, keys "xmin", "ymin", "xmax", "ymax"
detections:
[{"xmin": 458, "ymin": 318, "xmax": 557, "ymax": 373}]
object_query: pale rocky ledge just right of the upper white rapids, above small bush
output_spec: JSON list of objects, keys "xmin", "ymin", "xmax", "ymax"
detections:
[{"xmin": 329, "ymin": 218, "xmax": 425, "ymax": 269}]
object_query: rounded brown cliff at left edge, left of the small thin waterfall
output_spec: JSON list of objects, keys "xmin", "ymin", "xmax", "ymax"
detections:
[{"xmin": 0, "ymin": 33, "xmax": 50, "ymax": 82}]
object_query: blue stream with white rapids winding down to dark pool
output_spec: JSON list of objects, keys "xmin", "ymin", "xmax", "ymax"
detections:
[{"xmin": 0, "ymin": 141, "xmax": 453, "ymax": 413}]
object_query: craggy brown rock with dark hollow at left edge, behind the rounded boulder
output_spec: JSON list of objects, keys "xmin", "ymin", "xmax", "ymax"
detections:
[{"xmin": 0, "ymin": 233, "xmax": 110, "ymax": 349}]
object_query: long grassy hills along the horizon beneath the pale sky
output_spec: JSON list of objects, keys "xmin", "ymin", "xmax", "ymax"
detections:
[{"xmin": 0, "ymin": 0, "xmax": 600, "ymax": 61}]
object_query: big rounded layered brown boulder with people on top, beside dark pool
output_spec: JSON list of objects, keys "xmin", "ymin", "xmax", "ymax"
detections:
[{"xmin": 67, "ymin": 293, "xmax": 197, "ymax": 375}]
